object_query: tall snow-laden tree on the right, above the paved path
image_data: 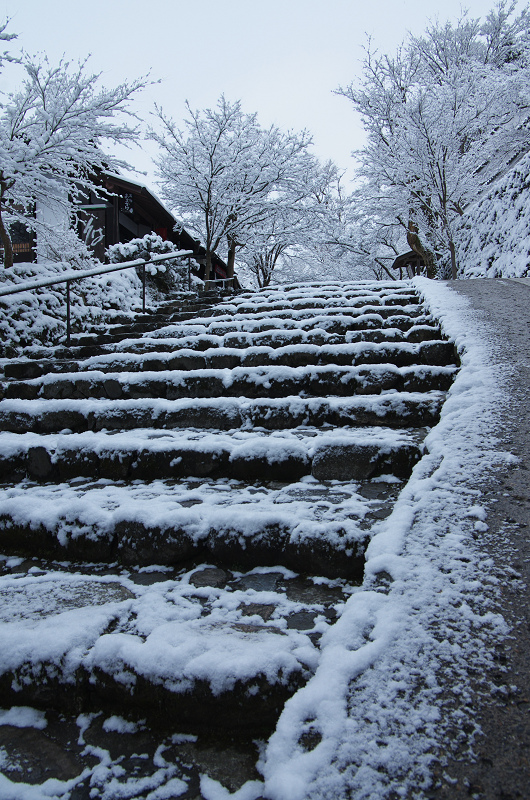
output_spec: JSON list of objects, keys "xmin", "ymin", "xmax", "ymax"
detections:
[{"xmin": 339, "ymin": 0, "xmax": 530, "ymax": 278}]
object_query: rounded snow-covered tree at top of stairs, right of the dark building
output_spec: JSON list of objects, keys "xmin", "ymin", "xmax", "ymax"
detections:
[{"xmin": 151, "ymin": 97, "xmax": 320, "ymax": 280}]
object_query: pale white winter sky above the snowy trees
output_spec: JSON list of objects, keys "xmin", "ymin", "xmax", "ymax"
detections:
[{"xmin": 0, "ymin": 0, "xmax": 504, "ymax": 191}]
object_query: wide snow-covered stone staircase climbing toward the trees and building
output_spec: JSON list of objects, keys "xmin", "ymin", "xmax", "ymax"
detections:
[{"xmin": 0, "ymin": 283, "xmax": 457, "ymax": 792}]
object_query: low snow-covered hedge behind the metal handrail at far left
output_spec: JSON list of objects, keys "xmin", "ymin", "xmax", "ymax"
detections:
[{"xmin": 0, "ymin": 262, "xmax": 141, "ymax": 357}]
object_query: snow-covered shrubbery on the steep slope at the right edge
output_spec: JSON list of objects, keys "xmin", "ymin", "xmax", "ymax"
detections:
[{"xmin": 458, "ymin": 154, "xmax": 530, "ymax": 278}]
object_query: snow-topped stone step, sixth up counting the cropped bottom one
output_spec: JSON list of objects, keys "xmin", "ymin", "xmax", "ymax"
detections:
[{"xmin": 4, "ymin": 362, "xmax": 456, "ymax": 400}]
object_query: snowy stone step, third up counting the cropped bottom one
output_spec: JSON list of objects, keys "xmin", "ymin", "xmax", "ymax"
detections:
[{"xmin": 0, "ymin": 468, "xmax": 404, "ymax": 580}]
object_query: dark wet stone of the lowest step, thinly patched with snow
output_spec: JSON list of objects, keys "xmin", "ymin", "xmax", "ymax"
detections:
[{"xmin": 0, "ymin": 711, "xmax": 261, "ymax": 800}]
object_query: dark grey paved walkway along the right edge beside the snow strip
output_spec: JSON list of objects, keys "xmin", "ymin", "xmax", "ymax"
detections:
[{"xmin": 427, "ymin": 279, "xmax": 530, "ymax": 800}]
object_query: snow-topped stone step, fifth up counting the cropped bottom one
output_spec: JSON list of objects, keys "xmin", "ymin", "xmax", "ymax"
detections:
[{"xmin": 0, "ymin": 391, "xmax": 445, "ymax": 433}]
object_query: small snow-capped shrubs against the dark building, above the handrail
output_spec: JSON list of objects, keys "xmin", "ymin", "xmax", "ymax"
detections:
[{"xmin": 106, "ymin": 233, "xmax": 203, "ymax": 295}]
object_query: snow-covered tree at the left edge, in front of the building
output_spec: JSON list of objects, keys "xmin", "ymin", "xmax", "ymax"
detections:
[{"xmin": 0, "ymin": 50, "xmax": 146, "ymax": 267}]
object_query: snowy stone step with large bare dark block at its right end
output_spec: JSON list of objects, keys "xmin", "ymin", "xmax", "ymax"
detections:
[{"xmin": 0, "ymin": 428, "xmax": 425, "ymax": 483}]
